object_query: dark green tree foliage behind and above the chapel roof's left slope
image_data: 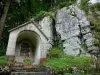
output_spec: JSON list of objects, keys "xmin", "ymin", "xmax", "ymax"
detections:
[{"xmin": 0, "ymin": 0, "xmax": 49, "ymax": 56}]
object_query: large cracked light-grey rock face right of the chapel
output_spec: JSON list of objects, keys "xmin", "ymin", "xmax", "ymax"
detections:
[{"xmin": 56, "ymin": 5, "xmax": 93, "ymax": 55}]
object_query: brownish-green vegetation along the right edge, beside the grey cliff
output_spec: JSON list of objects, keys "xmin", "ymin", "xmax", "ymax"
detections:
[{"xmin": 88, "ymin": 3, "xmax": 100, "ymax": 47}]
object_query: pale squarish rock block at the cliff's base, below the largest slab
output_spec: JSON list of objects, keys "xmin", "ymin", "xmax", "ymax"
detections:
[{"xmin": 63, "ymin": 37, "xmax": 81, "ymax": 55}]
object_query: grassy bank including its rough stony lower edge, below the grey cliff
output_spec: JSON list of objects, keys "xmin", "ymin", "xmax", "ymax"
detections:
[{"xmin": 42, "ymin": 55, "xmax": 93, "ymax": 75}]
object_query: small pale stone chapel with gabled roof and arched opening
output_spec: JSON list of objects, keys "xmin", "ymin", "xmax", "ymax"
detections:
[{"xmin": 6, "ymin": 21, "xmax": 51, "ymax": 64}]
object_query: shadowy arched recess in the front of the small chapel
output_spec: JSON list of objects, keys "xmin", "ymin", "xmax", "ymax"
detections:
[{"xmin": 15, "ymin": 30, "xmax": 41, "ymax": 64}]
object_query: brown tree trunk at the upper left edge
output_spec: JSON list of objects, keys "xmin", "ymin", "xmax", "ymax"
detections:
[{"xmin": 0, "ymin": 0, "xmax": 10, "ymax": 40}]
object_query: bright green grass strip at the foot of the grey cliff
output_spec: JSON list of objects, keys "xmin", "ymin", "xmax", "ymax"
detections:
[{"xmin": 43, "ymin": 55, "xmax": 92, "ymax": 70}]
